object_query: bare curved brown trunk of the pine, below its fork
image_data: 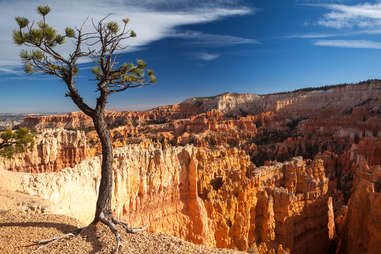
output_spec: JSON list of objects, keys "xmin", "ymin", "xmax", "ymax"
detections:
[{"xmin": 93, "ymin": 112, "xmax": 113, "ymax": 223}]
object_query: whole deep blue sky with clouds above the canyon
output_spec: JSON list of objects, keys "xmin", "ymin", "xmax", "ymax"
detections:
[{"xmin": 0, "ymin": 0, "xmax": 381, "ymax": 112}]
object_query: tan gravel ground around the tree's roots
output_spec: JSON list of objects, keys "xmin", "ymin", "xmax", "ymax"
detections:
[{"xmin": 0, "ymin": 210, "xmax": 242, "ymax": 254}]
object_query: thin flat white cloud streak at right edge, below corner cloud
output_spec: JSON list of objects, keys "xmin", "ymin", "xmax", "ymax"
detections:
[{"xmin": 314, "ymin": 40, "xmax": 381, "ymax": 49}]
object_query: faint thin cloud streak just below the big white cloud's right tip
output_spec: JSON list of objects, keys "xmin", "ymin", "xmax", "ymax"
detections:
[{"xmin": 171, "ymin": 31, "xmax": 260, "ymax": 47}]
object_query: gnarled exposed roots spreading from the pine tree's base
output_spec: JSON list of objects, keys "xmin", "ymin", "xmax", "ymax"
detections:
[{"xmin": 30, "ymin": 213, "xmax": 146, "ymax": 254}]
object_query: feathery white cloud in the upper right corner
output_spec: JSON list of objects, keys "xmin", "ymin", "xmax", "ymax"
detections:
[{"xmin": 312, "ymin": 3, "xmax": 381, "ymax": 29}]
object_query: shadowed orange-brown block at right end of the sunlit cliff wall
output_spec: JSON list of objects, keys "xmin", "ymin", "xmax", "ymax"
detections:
[{"xmin": 246, "ymin": 157, "xmax": 335, "ymax": 253}]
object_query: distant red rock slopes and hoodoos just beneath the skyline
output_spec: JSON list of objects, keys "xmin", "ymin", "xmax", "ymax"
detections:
[{"xmin": 14, "ymin": 81, "xmax": 381, "ymax": 173}]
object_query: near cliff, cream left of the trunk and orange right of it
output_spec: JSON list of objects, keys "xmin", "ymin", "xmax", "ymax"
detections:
[{"xmin": 0, "ymin": 144, "xmax": 334, "ymax": 253}]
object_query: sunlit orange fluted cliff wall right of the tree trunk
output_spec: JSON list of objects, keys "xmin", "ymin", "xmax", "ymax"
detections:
[{"xmin": 110, "ymin": 148, "xmax": 335, "ymax": 253}]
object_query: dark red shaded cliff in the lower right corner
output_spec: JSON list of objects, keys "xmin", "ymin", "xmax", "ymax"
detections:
[{"xmin": 338, "ymin": 160, "xmax": 381, "ymax": 254}]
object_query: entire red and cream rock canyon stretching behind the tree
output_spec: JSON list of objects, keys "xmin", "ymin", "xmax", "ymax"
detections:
[{"xmin": 0, "ymin": 80, "xmax": 381, "ymax": 254}]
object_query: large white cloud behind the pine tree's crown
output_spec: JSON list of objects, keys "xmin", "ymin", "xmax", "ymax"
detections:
[{"xmin": 0, "ymin": 0, "xmax": 252, "ymax": 69}]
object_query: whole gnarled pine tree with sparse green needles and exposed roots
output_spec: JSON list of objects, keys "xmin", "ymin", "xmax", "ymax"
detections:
[{"xmin": 13, "ymin": 6, "xmax": 156, "ymax": 253}]
